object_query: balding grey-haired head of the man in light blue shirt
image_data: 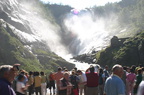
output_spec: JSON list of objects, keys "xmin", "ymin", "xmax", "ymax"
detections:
[{"xmin": 112, "ymin": 64, "xmax": 124, "ymax": 77}]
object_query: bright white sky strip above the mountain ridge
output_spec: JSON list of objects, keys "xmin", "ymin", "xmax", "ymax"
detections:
[{"xmin": 41, "ymin": 0, "xmax": 121, "ymax": 9}]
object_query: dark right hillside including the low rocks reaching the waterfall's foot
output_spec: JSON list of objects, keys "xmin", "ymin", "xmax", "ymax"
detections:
[{"xmin": 73, "ymin": 31, "xmax": 144, "ymax": 67}]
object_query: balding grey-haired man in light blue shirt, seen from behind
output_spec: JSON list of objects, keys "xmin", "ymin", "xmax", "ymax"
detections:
[{"xmin": 104, "ymin": 64, "xmax": 126, "ymax": 95}]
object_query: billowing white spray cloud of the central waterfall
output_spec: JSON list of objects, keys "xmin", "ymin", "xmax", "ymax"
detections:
[{"xmin": 64, "ymin": 12, "xmax": 117, "ymax": 55}]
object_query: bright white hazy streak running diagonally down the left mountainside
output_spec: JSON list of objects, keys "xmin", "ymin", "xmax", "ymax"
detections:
[{"xmin": 0, "ymin": 0, "xmax": 70, "ymax": 56}]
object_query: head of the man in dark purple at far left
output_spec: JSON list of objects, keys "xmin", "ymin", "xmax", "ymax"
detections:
[{"xmin": 0, "ymin": 65, "xmax": 18, "ymax": 82}]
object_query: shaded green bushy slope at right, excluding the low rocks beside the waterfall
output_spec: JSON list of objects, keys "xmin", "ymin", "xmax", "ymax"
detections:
[{"xmin": 98, "ymin": 31, "xmax": 144, "ymax": 66}]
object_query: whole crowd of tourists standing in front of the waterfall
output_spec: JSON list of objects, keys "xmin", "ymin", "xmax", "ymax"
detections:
[{"xmin": 0, "ymin": 64, "xmax": 144, "ymax": 95}]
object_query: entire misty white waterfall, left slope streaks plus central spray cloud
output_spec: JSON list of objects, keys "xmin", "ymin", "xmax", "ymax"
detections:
[{"xmin": 0, "ymin": 0, "xmax": 122, "ymax": 68}]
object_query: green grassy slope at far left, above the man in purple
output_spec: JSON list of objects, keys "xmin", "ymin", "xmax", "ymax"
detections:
[{"xmin": 0, "ymin": 22, "xmax": 42, "ymax": 70}]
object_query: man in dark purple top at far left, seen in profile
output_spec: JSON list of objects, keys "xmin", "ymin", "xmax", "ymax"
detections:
[{"xmin": 0, "ymin": 64, "xmax": 19, "ymax": 95}]
